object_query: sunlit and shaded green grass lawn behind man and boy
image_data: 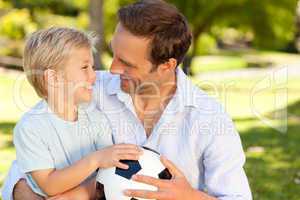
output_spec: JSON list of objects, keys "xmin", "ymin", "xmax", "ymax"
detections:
[{"xmin": 0, "ymin": 65, "xmax": 300, "ymax": 200}]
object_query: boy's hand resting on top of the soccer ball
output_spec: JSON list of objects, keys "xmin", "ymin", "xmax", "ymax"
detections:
[{"xmin": 96, "ymin": 144, "xmax": 143, "ymax": 169}]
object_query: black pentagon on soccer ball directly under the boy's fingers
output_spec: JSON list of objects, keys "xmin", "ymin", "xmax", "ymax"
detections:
[{"xmin": 115, "ymin": 160, "xmax": 142, "ymax": 180}]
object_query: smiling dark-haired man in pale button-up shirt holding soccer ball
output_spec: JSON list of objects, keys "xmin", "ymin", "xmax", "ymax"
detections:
[{"xmin": 2, "ymin": 0, "xmax": 252, "ymax": 200}]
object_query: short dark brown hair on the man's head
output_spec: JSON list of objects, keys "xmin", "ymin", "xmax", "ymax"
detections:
[{"xmin": 118, "ymin": 0, "xmax": 192, "ymax": 68}]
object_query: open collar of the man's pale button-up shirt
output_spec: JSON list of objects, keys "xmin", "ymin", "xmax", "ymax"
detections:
[{"xmin": 106, "ymin": 67, "xmax": 202, "ymax": 107}]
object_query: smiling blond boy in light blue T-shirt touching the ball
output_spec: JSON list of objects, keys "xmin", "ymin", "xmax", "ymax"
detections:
[{"xmin": 14, "ymin": 28, "xmax": 141, "ymax": 197}]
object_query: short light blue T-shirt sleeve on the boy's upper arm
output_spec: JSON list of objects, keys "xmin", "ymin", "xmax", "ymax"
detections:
[{"xmin": 14, "ymin": 120, "xmax": 54, "ymax": 173}]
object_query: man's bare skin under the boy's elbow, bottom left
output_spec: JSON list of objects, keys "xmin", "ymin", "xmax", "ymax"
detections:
[{"xmin": 13, "ymin": 179, "xmax": 44, "ymax": 200}]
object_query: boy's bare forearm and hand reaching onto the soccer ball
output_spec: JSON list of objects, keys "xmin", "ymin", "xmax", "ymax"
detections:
[{"xmin": 31, "ymin": 144, "xmax": 142, "ymax": 196}]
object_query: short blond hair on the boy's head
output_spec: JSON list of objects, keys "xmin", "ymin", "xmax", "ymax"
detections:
[{"xmin": 23, "ymin": 27, "xmax": 97, "ymax": 98}]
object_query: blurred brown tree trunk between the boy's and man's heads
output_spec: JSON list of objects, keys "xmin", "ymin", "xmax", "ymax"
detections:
[{"xmin": 89, "ymin": 0, "xmax": 104, "ymax": 70}]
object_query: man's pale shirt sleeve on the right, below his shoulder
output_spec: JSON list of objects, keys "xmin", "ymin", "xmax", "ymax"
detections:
[{"xmin": 203, "ymin": 113, "xmax": 252, "ymax": 200}]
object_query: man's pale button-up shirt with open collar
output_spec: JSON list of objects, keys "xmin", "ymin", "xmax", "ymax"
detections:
[{"xmin": 3, "ymin": 69, "xmax": 252, "ymax": 200}]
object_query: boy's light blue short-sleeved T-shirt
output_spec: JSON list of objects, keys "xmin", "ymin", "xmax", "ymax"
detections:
[{"xmin": 14, "ymin": 100, "xmax": 113, "ymax": 196}]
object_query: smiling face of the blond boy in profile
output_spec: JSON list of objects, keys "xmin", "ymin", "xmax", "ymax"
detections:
[{"xmin": 62, "ymin": 48, "xmax": 96, "ymax": 105}]
